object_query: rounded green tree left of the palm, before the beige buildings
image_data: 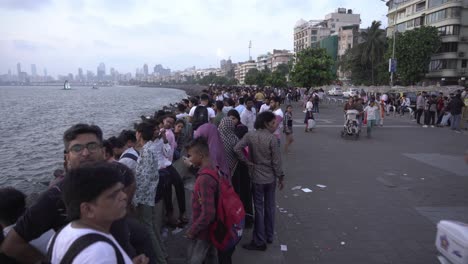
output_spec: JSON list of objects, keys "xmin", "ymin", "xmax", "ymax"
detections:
[{"xmin": 290, "ymin": 48, "xmax": 335, "ymax": 87}]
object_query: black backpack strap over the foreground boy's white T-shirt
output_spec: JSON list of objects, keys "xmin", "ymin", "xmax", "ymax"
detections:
[{"xmin": 59, "ymin": 233, "xmax": 125, "ymax": 264}]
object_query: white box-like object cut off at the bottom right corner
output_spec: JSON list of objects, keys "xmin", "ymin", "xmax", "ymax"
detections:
[{"xmin": 436, "ymin": 220, "xmax": 468, "ymax": 264}]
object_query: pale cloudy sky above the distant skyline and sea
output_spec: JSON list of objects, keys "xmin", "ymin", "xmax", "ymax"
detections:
[{"xmin": 0, "ymin": 0, "xmax": 387, "ymax": 76}]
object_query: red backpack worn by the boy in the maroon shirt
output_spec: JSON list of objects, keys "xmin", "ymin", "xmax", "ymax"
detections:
[{"xmin": 199, "ymin": 169, "xmax": 245, "ymax": 251}]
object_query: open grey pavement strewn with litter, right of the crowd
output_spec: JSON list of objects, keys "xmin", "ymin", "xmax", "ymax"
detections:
[{"xmin": 163, "ymin": 101, "xmax": 468, "ymax": 264}]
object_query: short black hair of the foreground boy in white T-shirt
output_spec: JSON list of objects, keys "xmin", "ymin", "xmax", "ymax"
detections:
[{"xmin": 62, "ymin": 162, "xmax": 122, "ymax": 221}]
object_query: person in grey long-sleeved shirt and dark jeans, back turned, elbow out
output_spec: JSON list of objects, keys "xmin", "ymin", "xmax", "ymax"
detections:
[{"xmin": 234, "ymin": 112, "xmax": 284, "ymax": 251}]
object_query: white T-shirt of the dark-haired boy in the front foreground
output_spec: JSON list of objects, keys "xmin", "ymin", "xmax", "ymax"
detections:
[{"xmin": 49, "ymin": 223, "xmax": 133, "ymax": 264}]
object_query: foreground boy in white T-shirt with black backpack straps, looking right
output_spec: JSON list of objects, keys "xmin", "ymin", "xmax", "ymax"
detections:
[{"xmin": 49, "ymin": 162, "xmax": 148, "ymax": 264}]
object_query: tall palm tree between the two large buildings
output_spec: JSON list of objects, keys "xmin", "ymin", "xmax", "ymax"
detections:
[{"xmin": 361, "ymin": 20, "xmax": 387, "ymax": 84}]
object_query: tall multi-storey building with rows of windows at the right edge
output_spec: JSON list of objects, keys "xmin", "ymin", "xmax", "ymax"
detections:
[{"xmin": 387, "ymin": 0, "xmax": 468, "ymax": 84}]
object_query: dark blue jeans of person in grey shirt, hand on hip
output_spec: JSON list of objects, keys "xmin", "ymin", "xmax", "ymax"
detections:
[{"xmin": 252, "ymin": 181, "xmax": 276, "ymax": 246}]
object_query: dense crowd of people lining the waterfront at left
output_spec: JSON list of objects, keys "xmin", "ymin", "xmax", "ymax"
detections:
[{"xmin": 0, "ymin": 87, "xmax": 305, "ymax": 263}]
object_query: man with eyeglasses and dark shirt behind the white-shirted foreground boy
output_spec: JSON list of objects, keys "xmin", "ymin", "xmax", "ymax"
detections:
[{"xmin": 0, "ymin": 124, "xmax": 132, "ymax": 263}]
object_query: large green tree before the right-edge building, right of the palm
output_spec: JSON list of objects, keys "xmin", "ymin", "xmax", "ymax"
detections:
[{"xmin": 387, "ymin": 26, "xmax": 441, "ymax": 85}]
